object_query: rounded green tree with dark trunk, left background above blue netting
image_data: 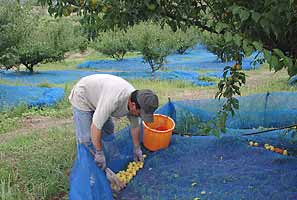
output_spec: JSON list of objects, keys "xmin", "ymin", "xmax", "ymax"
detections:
[{"xmin": 18, "ymin": 18, "xmax": 84, "ymax": 71}]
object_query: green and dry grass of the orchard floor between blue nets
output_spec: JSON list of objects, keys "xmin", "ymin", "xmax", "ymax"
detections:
[{"xmin": 0, "ymin": 52, "xmax": 297, "ymax": 200}]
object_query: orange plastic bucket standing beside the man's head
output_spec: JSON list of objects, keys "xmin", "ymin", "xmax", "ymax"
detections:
[{"xmin": 143, "ymin": 114, "xmax": 175, "ymax": 151}]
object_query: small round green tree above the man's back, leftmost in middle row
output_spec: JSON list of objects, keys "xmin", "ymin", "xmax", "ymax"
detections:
[{"xmin": 92, "ymin": 29, "xmax": 132, "ymax": 60}]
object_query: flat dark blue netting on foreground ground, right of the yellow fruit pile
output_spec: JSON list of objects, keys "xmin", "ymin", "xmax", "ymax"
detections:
[{"xmin": 120, "ymin": 136, "xmax": 297, "ymax": 200}]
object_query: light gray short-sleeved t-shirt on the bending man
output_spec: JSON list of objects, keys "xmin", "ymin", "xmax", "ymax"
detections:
[{"xmin": 69, "ymin": 74, "xmax": 140, "ymax": 129}]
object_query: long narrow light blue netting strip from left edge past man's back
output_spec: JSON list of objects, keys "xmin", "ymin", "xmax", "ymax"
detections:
[{"xmin": 0, "ymin": 70, "xmax": 215, "ymax": 86}]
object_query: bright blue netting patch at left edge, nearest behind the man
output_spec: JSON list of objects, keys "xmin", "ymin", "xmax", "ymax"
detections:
[{"xmin": 0, "ymin": 84, "xmax": 65, "ymax": 110}]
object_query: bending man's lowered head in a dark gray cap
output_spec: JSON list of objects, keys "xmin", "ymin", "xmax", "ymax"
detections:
[{"xmin": 128, "ymin": 90, "xmax": 159, "ymax": 122}]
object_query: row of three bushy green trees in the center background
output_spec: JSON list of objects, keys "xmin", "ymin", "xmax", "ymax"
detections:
[{"xmin": 92, "ymin": 21, "xmax": 200, "ymax": 73}]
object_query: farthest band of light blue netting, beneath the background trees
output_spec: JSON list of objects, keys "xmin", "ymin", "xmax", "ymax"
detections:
[{"xmin": 78, "ymin": 45, "xmax": 261, "ymax": 71}]
